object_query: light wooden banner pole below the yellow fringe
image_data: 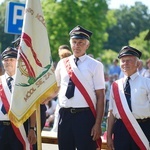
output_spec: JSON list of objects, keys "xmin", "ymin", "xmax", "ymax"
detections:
[{"xmin": 36, "ymin": 105, "xmax": 42, "ymax": 150}]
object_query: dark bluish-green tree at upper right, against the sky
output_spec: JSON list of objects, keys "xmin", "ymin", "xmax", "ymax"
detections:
[{"xmin": 104, "ymin": 2, "xmax": 150, "ymax": 51}]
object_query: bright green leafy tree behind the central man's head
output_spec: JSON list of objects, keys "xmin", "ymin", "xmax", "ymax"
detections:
[{"xmin": 42, "ymin": 0, "xmax": 108, "ymax": 60}]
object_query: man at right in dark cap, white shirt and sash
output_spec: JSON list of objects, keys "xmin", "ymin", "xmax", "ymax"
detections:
[{"xmin": 107, "ymin": 46, "xmax": 150, "ymax": 150}]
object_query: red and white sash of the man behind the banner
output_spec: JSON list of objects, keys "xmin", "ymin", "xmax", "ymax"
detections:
[{"xmin": 0, "ymin": 77, "xmax": 32, "ymax": 150}]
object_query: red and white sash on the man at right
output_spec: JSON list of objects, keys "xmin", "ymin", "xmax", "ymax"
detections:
[{"xmin": 113, "ymin": 79, "xmax": 150, "ymax": 150}]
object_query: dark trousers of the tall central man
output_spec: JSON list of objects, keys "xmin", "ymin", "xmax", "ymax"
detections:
[{"xmin": 58, "ymin": 109, "xmax": 96, "ymax": 150}]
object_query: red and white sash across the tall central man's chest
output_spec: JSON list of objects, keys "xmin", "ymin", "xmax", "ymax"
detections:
[{"xmin": 64, "ymin": 57, "xmax": 102, "ymax": 148}]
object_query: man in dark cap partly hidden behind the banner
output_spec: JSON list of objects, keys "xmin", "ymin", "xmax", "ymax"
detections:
[{"xmin": 0, "ymin": 47, "xmax": 36, "ymax": 150}]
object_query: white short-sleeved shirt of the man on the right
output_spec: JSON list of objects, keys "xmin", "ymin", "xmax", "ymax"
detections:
[{"xmin": 109, "ymin": 73, "xmax": 150, "ymax": 119}]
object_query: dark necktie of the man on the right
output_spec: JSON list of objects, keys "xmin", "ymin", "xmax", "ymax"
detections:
[{"xmin": 124, "ymin": 77, "xmax": 132, "ymax": 111}]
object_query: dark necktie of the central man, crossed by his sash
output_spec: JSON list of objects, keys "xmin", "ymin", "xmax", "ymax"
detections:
[{"xmin": 65, "ymin": 58, "xmax": 79, "ymax": 99}]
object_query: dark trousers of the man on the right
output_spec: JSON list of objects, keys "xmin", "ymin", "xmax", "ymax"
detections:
[{"xmin": 114, "ymin": 119, "xmax": 150, "ymax": 150}]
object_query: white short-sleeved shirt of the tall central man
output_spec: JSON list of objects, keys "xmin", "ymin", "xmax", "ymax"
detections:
[{"xmin": 55, "ymin": 55, "xmax": 105, "ymax": 108}]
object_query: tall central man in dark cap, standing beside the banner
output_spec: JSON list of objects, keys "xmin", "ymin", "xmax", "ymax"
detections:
[{"xmin": 55, "ymin": 26, "xmax": 105, "ymax": 150}]
